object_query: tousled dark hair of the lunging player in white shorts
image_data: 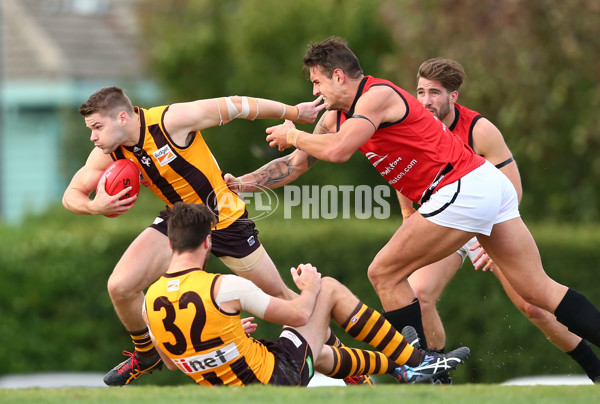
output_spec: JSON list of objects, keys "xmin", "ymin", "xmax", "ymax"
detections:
[{"xmin": 303, "ymin": 37, "xmax": 363, "ymax": 79}]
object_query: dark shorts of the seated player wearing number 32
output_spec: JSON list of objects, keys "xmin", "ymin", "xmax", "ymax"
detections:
[{"xmin": 260, "ymin": 327, "xmax": 314, "ymax": 386}]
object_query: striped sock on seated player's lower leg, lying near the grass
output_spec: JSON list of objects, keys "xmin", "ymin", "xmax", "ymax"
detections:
[{"xmin": 325, "ymin": 346, "xmax": 398, "ymax": 379}]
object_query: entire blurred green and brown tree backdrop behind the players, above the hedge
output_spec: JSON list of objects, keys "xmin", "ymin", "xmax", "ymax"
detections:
[{"xmin": 136, "ymin": 0, "xmax": 600, "ymax": 220}]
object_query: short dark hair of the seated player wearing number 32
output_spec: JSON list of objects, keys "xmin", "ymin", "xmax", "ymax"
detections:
[{"xmin": 167, "ymin": 202, "xmax": 217, "ymax": 253}]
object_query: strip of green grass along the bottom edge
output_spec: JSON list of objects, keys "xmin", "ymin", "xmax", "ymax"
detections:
[{"xmin": 0, "ymin": 384, "xmax": 600, "ymax": 404}]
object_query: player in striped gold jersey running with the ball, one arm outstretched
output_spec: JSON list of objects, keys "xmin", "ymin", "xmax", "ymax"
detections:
[{"xmin": 63, "ymin": 87, "xmax": 323, "ymax": 385}]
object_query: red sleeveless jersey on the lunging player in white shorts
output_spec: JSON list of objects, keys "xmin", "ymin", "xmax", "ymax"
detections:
[{"xmin": 337, "ymin": 76, "xmax": 485, "ymax": 203}]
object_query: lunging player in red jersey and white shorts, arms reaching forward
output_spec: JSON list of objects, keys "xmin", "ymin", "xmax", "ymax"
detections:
[{"xmin": 226, "ymin": 38, "xmax": 600, "ymax": 382}]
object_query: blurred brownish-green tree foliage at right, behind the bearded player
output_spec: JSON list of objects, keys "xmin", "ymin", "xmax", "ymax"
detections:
[{"xmin": 384, "ymin": 0, "xmax": 600, "ymax": 220}]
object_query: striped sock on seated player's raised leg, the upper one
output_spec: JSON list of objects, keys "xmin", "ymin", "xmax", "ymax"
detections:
[{"xmin": 342, "ymin": 302, "xmax": 422, "ymax": 366}]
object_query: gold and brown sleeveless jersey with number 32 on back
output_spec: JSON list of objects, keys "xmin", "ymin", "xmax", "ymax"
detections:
[{"xmin": 145, "ymin": 268, "xmax": 275, "ymax": 386}]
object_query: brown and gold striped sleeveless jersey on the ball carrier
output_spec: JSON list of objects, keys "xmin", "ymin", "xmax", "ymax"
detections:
[{"xmin": 112, "ymin": 106, "xmax": 246, "ymax": 229}]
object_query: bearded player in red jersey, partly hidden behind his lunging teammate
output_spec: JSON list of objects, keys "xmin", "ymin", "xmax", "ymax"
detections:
[{"xmin": 398, "ymin": 58, "xmax": 600, "ymax": 382}]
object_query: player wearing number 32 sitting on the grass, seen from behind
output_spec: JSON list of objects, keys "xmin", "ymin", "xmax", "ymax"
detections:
[{"xmin": 144, "ymin": 202, "xmax": 469, "ymax": 386}]
